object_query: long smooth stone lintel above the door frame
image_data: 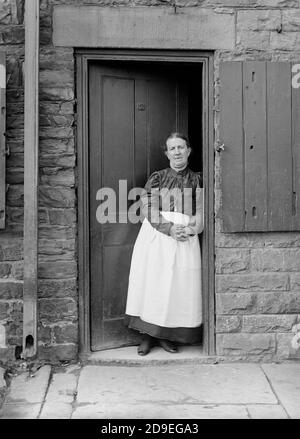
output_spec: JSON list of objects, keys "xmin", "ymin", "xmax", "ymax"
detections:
[{"xmin": 53, "ymin": 6, "xmax": 235, "ymax": 50}]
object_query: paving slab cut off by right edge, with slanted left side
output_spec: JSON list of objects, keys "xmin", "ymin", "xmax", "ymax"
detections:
[{"xmin": 262, "ymin": 362, "xmax": 300, "ymax": 419}]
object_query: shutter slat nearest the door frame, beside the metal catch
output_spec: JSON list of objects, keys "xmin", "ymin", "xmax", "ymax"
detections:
[{"xmin": 220, "ymin": 61, "xmax": 245, "ymax": 232}]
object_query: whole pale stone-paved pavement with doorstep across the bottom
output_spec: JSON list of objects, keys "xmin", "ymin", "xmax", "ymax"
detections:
[{"xmin": 0, "ymin": 347, "xmax": 300, "ymax": 419}]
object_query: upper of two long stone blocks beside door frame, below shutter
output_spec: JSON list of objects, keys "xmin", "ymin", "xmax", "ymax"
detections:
[{"xmin": 216, "ymin": 273, "xmax": 289, "ymax": 293}]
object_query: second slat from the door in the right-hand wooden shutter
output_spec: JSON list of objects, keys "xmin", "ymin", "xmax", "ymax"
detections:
[{"xmin": 243, "ymin": 61, "xmax": 268, "ymax": 231}]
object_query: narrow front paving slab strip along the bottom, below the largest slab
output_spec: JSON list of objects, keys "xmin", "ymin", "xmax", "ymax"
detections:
[{"xmin": 72, "ymin": 403, "xmax": 249, "ymax": 419}]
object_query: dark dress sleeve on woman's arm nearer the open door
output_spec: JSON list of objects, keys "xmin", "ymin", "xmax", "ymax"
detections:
[{"xmin": 141, "ymin": 172, "xmax": 173, "ymax": 235}]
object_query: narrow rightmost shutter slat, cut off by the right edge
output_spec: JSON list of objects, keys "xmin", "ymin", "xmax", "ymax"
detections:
[{"xmin": 292, "ymin": 64, "xmax": 300, "ymax": 234}]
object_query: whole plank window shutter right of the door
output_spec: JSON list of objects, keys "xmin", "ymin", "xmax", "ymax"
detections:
[{"xmin": 219, "ymin": 61, "xmax": 300, "ymax": 232}]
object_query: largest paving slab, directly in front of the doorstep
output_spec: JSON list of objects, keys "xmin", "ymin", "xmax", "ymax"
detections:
[{"xmin": 77, "ymin": 364, "xmax": 277, "ymax": 405}]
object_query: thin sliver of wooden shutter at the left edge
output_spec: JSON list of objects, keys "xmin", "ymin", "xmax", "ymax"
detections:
[{"xmin": 0, "ymin": 53, "xmax": 6, "ymax": 229}]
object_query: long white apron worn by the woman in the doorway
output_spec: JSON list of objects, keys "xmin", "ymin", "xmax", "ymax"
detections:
[{"xmin": 126, "ymin": 212, "xmax": 202, "ymax": 328}]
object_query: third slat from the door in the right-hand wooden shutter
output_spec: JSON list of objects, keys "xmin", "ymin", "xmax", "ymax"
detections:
[{"xmin": 267, "ymin": 62, "xmax": 292, "ymax": 231}]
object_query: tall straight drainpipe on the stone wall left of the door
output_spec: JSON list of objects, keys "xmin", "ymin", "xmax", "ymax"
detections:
[{"xmin": 22, "ymin": 0, "xmax": 40, "ymax": 359}]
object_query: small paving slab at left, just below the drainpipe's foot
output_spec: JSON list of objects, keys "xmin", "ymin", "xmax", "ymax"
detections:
[{"xmin": 5, "ymin": 365, "xmax": 51, "ymax": 404}]
